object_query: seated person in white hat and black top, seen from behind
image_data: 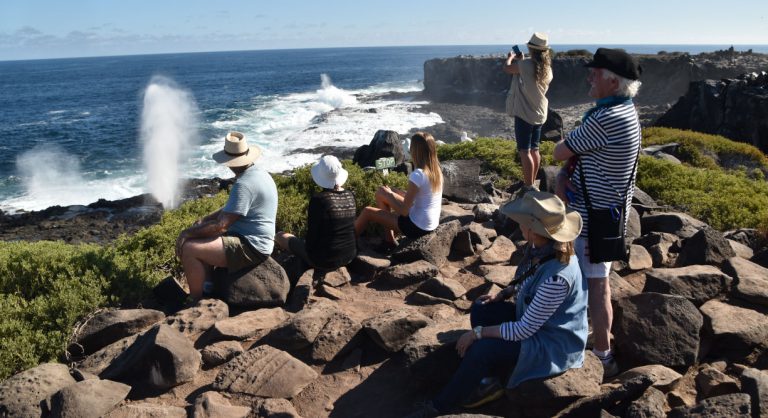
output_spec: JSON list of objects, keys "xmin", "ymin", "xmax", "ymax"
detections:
[{"xmin": 275, "ymin": 155, "xmax": 357, "ymax": 270}]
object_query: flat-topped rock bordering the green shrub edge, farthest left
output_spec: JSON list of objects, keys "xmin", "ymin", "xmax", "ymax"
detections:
[{"xmin": 67, "ymin": 309, "xmax": 165, "ymax": 355}]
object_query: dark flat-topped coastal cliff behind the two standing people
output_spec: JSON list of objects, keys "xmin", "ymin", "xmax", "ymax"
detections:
[{"xmin": 424, "ymin": 51, "xmax": 768, "ymax": 110}]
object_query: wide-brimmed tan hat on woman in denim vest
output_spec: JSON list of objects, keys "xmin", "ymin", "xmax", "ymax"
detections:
[{"xmin": 499, "ymin": 191, "xmax": 581, "ymax": 242}]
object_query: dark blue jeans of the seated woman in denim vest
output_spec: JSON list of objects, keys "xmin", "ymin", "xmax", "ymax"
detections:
[{"xmin": 432, "ymin": 302, "xmax": 520, "ymax": 413}]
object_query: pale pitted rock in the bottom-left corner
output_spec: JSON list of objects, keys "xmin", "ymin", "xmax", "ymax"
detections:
[{"xmin": 0, "ymin": 363, "xmax": 75, "ymax": 417}]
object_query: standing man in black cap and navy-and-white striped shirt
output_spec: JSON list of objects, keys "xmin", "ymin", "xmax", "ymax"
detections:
[{"xmin": 554, "ymin": 48, "xmax": 642, "ymax": 377}]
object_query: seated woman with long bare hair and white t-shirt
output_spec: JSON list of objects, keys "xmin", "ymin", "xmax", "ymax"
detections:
[{"xmin": 355, "ymin": 132, "xmax": 443, "ymax": 244}]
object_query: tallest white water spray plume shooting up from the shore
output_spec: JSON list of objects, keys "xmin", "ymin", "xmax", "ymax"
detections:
[{"xmin": 141, "ymin": 76, "xmax": 199, "ymax": 209}]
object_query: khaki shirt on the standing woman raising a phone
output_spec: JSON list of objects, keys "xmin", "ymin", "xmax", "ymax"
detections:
[{"xmin": 506, "ymin": 59, "xmax": 552, "ymax": 125}]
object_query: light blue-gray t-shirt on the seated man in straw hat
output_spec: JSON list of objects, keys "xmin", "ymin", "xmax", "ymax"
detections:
[{"xmin": 222, "ymin": 166, "xmax": 277, "ymax": 255}]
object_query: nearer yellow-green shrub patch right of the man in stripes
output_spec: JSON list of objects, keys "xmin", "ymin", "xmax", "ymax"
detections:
[{"xmin": 637, "ymin": 157, "xmax": 768, "ymax": 230}]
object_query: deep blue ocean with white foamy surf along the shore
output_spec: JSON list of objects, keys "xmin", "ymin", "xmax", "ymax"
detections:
[{"xmin": 0, "ymin": 45, "xmax": 768, "ymax": 213}]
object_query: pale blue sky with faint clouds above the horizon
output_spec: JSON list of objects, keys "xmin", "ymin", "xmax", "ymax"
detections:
[{"xmin": 0, "ymin": 0, "xmax": 768, "ymax": 60}]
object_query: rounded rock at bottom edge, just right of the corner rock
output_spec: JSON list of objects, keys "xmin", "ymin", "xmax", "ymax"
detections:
[{"xmin": 51, "ymin": 380, "xmax": 131, "ymax": 418}]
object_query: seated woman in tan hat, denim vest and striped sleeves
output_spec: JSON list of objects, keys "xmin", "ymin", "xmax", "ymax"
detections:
[{"xmin": 411, "ymin": 191, "xmax": 587, "ymax": 417}]
